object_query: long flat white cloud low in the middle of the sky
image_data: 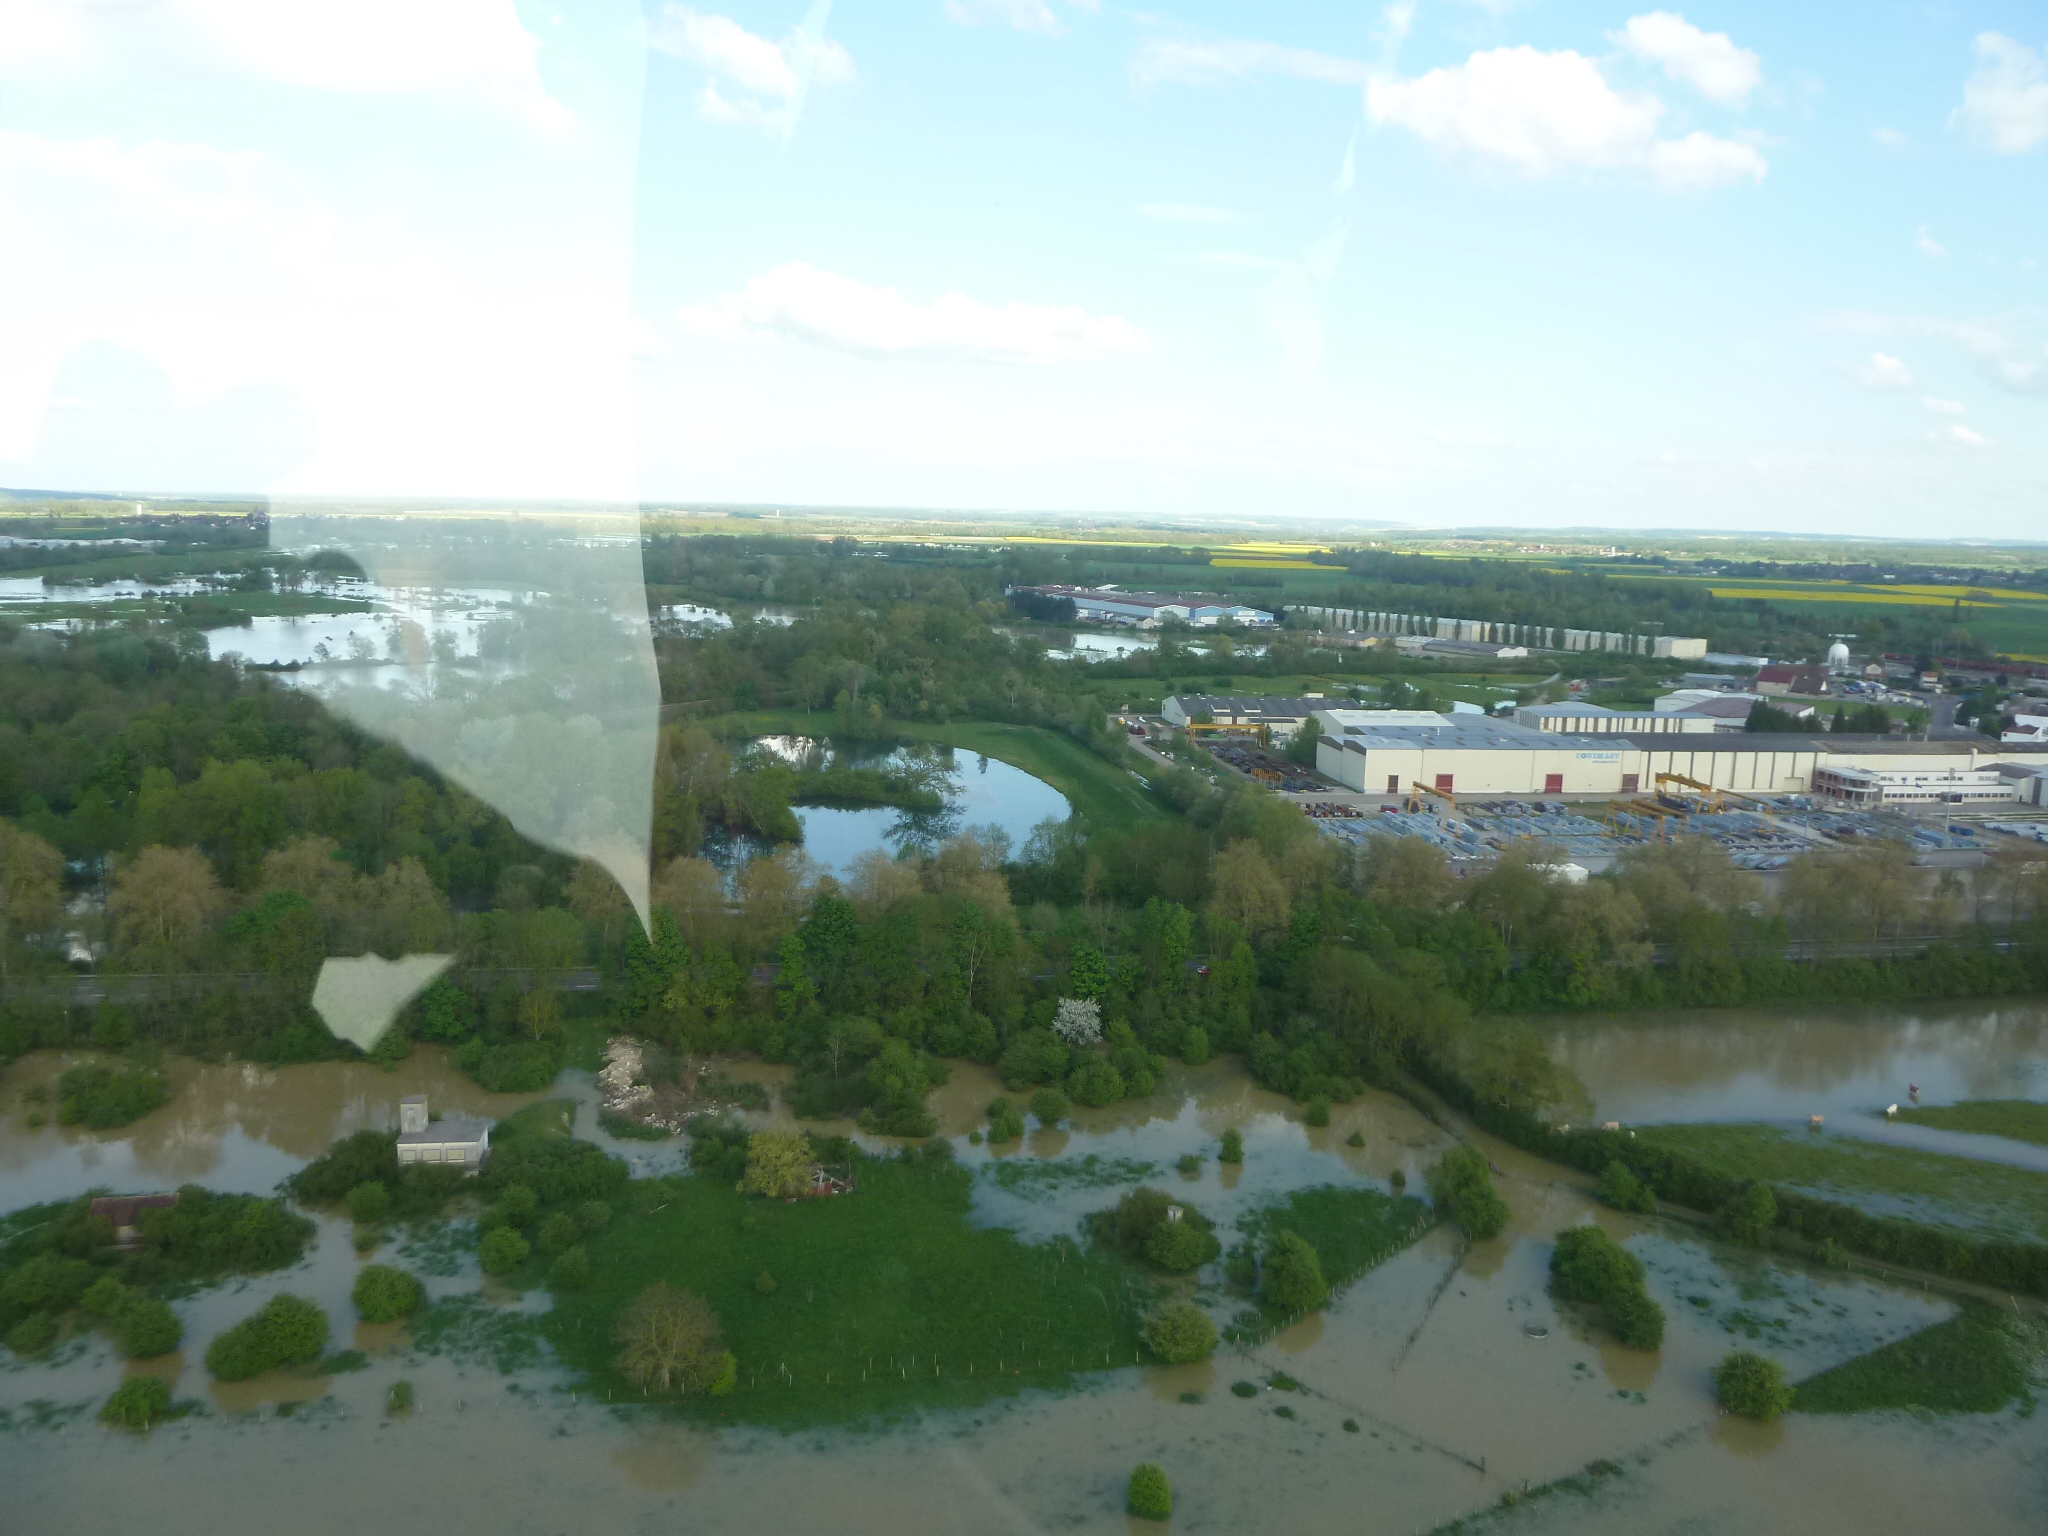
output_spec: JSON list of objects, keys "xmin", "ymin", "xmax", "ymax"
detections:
[{"xmin": 676, "ymin": 262, "xmax": 1147, "ymax": 365}]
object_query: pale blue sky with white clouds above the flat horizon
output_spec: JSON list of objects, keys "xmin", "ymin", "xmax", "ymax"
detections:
[{"xmin": 0, "ymin": 0, "xmax": 2048, "ymax": 539}]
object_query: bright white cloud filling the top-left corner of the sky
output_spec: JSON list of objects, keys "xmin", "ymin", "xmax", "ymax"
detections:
[{"xmin": 0, "ymin": 0, "xmax": 573, "ymax": 135}]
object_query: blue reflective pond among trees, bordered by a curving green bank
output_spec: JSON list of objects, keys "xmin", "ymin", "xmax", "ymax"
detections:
[{"xmin": 758, "ymin": 735, "xmax": 1073, "ymax": 877}]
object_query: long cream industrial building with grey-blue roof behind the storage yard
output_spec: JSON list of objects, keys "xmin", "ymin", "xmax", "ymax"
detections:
[{"xmin": 1315, "ymin": 709, "xmax": 2048, "ymax": 799}]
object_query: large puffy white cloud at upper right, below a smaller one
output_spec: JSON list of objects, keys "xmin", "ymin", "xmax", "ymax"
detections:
[{"xmin": 1366, "ymin": 47, "xmax": 1769, "ymax": 190}]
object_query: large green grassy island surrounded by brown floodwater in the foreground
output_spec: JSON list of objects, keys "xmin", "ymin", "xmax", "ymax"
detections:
[{"xmin": 547, "ymin": 1153, "xmax": 1155, "ymax": 1425}]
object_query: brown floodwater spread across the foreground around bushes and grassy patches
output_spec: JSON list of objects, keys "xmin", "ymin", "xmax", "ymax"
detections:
[{"xmin": 0, "ymin": 1028, "xmax": 2048, "ymax": 1536}]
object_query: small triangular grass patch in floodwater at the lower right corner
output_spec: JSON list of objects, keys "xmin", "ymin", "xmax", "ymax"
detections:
[{"xmin": 1792, "ymin": 1307, "xmax": 2036, "ymax": 1413}]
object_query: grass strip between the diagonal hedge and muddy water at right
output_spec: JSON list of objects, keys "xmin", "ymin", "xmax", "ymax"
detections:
[{"xmin": 1636, "ymin": 1124, "xmax": 2048, "ymax": 1243}]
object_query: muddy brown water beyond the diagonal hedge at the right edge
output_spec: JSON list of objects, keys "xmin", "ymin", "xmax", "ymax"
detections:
[{"xmin": 1538, "ymin": 1001, "xmax": 2048, "ymax": 1167}]
